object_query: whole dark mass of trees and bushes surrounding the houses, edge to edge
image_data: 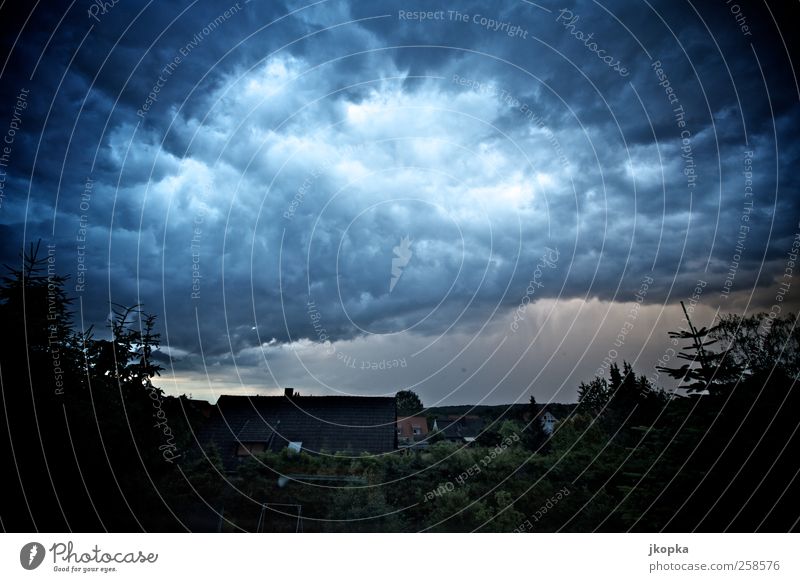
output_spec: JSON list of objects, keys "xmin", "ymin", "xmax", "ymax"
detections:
[{"xmin": 0, "ymin": 249, "xmax": 800, "ymax": 532}]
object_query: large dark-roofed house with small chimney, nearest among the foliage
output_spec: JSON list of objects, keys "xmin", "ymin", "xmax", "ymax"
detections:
[{"xmin": 197, "ymin": 388, "xmax": 396, "ymax": 470}]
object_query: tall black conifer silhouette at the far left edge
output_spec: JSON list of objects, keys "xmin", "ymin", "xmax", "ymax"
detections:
[{"xmin": 0, "ymin": 243, "xmax": 87, "ymax": 531}]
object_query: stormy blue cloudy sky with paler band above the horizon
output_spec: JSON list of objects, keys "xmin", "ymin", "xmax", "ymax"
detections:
[{"xmin": 0, "ymin": 0, "xmax": 800, "ymax": 405}]
